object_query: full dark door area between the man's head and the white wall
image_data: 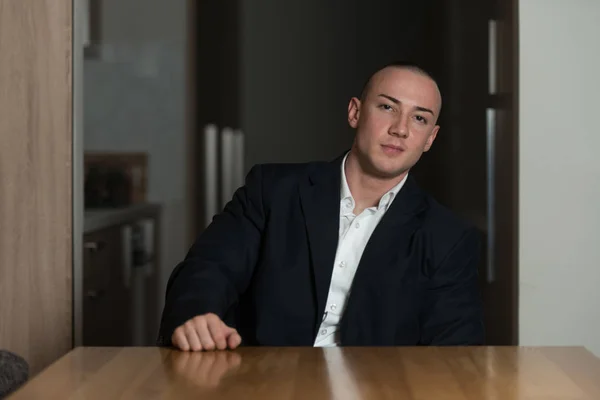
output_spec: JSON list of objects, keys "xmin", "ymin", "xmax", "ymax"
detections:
[{"xmin": 413, "ymin": 0, "xmax": 518, "ymax": 345}]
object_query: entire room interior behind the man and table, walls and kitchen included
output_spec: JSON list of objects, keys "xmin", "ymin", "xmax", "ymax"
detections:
[{"xmin": 0, "ymin": 0, "xmax": 600, "ymax": 378}]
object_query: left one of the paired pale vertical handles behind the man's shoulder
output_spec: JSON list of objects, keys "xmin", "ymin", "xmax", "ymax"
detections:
[{"xmin": 204, "ymin": 124, "xmax": 219, "ymax": 226}]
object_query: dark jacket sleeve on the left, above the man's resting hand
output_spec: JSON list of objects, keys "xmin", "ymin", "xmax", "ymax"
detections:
[{"xmin": 158, "ymin": 166, "xmax": 265, "ymax": 346}]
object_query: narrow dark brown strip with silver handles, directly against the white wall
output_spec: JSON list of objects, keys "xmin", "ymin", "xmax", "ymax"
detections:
[{"xmin": 482, "ymin": 0, "xmax": 519, "ymax": 345}]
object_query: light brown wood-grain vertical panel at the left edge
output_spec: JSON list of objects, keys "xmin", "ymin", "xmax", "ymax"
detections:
[{"xmin": 0, "ymin": 0, "xmax": 72, "ymax": 374}]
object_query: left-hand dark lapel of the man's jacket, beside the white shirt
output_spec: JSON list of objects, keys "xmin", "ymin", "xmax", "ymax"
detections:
[{"xmin": 300, "ymin": 157, "xmax": 343, "ymax": 332}]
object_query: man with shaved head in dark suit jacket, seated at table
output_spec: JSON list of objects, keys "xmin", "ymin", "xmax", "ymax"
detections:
[{"xmin": 159, "ymin": 64, "xmax": 484, "ymax": 351}]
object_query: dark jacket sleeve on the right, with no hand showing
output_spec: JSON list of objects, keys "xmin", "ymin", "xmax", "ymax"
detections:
[{"xmin": 420, "ymin": 229, "xmax": 485, "ymax": 346}]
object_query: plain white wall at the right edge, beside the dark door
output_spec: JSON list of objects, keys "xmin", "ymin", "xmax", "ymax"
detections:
[{"xmin": 519, "ymin": 0, "xmax": 600, "ymax": 356}]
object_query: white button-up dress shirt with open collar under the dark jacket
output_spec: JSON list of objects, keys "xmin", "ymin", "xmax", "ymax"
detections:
[{"xmin": 314, "ymin": 154, "xmax": 408, "ymax": 347}]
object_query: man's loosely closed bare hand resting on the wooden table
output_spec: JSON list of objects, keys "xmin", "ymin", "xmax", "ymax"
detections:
[{"xmin": 171, "ymin": 313, "xmax": 242, "ymax": 351}]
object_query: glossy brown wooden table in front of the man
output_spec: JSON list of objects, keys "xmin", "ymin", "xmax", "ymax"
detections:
[{"xmin": 11, "ymin": 347, "xmax": 600, "ymax": 400}]
